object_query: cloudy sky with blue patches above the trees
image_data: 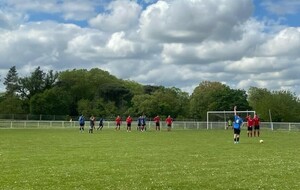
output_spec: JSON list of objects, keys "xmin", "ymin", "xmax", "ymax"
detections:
[{"xmin": 0, "ymin": 0, "xmax": 300, "ymax": 96}]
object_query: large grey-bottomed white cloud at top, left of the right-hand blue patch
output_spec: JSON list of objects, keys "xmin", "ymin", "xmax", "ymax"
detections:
[{"xmin": 140, "ymin": 0, "xmax": 253, "ymax": 43}]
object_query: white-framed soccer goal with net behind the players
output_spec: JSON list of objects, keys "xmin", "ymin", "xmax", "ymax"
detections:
[{"xmin": 206, "ymin": 110, "xmax": 255, "ymax": 129}]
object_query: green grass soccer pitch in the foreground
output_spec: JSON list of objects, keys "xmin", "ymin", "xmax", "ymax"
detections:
[{"xmin": 0, "ymin": 129, "xmax": 300, "ymax": 190}]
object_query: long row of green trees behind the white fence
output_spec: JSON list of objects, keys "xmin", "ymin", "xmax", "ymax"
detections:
[{"xmin": 0, "ymin": 66, "xmax": 300, "ymax": 122}]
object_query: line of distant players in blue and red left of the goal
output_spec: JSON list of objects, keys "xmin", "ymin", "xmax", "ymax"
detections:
[{"xmin": 78, "ymin": 115, "xmax": 173, "ymax": 133}]
